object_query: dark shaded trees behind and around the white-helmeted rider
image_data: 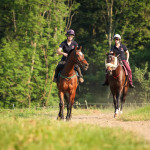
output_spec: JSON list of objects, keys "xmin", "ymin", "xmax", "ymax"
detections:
[{"xmin": 72, "ymin": 0, "xmax": 150, "ymax": 102}]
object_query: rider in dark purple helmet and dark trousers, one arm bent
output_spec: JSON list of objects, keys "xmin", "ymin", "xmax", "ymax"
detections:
[{"xmin": 53, "ymin": 29, "xmax": 84, "ymax": 83}]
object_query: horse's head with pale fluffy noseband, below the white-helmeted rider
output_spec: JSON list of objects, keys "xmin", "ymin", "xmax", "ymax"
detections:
[{"xmin": 105, "ymin": 53, "xmax": 118, "ymax": 75}]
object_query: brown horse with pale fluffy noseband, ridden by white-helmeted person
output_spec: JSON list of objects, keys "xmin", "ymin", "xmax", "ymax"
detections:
[{"xmin": 105, "ymin": 53, "xmax": 129, "ymax": 117}]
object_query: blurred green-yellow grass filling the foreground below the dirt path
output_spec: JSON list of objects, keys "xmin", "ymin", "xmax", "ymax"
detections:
[{"xmin": 0, "ymin": 109, "xmax": 150, "ymax": 150}]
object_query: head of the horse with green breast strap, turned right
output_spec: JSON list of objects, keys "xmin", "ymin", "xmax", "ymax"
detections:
[{"xmin": 74, "ymin": 46, "xmax": 89, "ymax": 70}]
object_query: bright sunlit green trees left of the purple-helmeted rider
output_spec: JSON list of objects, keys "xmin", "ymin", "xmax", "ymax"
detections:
[{"xmin": 0, "ymin": 0, "xmax": 78, "ymax": 108}]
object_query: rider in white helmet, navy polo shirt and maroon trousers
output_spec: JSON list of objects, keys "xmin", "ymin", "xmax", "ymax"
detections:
[{"xmin": 103, "ymin": 34, "xmax": 135, "ymax": 88}]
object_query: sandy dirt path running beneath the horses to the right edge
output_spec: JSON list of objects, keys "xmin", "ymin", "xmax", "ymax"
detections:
[{"xmin": 72, "ymin": 113, "xmax": 150, "ymax": 142}]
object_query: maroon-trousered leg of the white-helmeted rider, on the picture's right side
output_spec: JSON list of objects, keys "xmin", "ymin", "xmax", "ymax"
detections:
[{"xmin": 122, "ymin": 60, "xmax": 135, "ymax": 88}]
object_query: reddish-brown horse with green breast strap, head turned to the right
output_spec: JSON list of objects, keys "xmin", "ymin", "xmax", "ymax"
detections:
[{"xmin": 57, "ymin": 47, "xmax": 89, "ymax": 120}]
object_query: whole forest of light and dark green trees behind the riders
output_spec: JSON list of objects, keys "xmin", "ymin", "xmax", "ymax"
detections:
[{"xmin": 0, "ymin": 0, "xmax": 150, "ymax": 108}]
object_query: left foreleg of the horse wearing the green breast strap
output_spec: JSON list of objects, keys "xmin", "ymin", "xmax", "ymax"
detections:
[{"xmin": 57, "ymin": 92, "xmax": 64, "ymax": 119}]
